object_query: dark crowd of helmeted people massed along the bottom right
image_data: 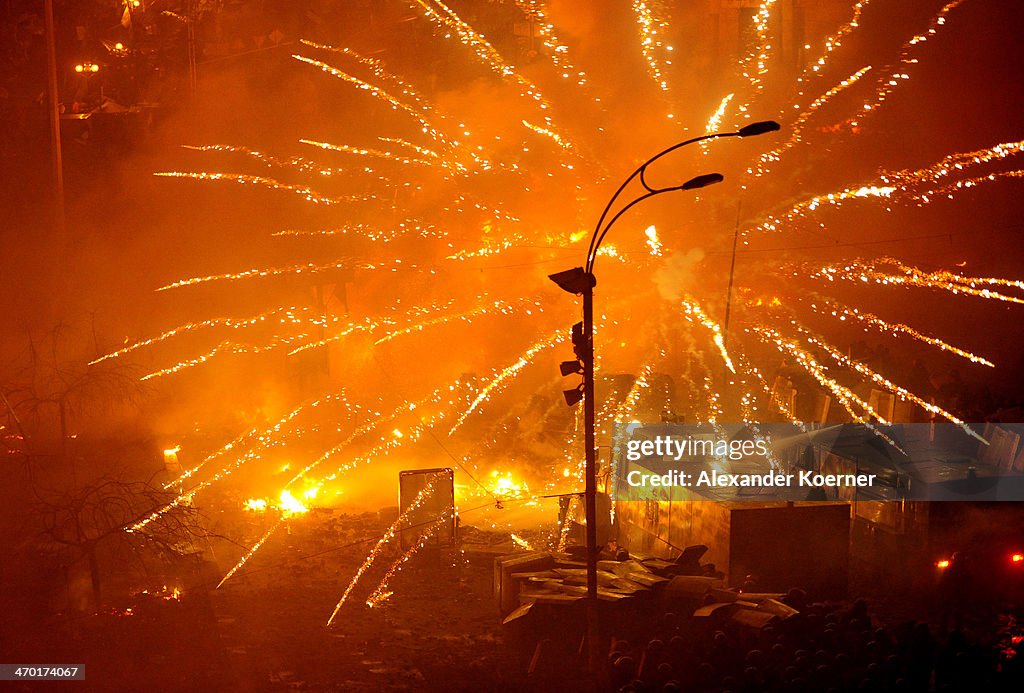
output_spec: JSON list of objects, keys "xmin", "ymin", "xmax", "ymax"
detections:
[{"xmin": 608, "ymin": 590, "xmax": 1024, "ymax": 693}]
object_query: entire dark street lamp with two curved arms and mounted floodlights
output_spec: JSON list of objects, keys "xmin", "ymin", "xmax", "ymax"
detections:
[{"xmin": 549, "ymin": 121, "xmax": 779, "ymax": 672}]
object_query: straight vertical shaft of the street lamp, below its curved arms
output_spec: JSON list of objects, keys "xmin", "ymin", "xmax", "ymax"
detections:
[{"xmin": 583, "ymin": 274, "xmax": 600, "ymax": 672}]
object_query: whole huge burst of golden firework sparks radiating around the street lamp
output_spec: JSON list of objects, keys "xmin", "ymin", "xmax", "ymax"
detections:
[{"xmin": 125, "ymin": 0, "xmax": 1024, "ymax": 625}]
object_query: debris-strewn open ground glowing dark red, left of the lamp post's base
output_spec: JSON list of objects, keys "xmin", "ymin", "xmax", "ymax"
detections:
[{"xmin": 0, "ymin": 515, "xmax": 521, "ymax": 691}]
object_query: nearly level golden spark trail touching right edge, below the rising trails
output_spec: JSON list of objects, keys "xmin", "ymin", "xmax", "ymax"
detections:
[{"xmin": 808, "ymin": 258, "xmax": 1024, "ymax": 304}]
